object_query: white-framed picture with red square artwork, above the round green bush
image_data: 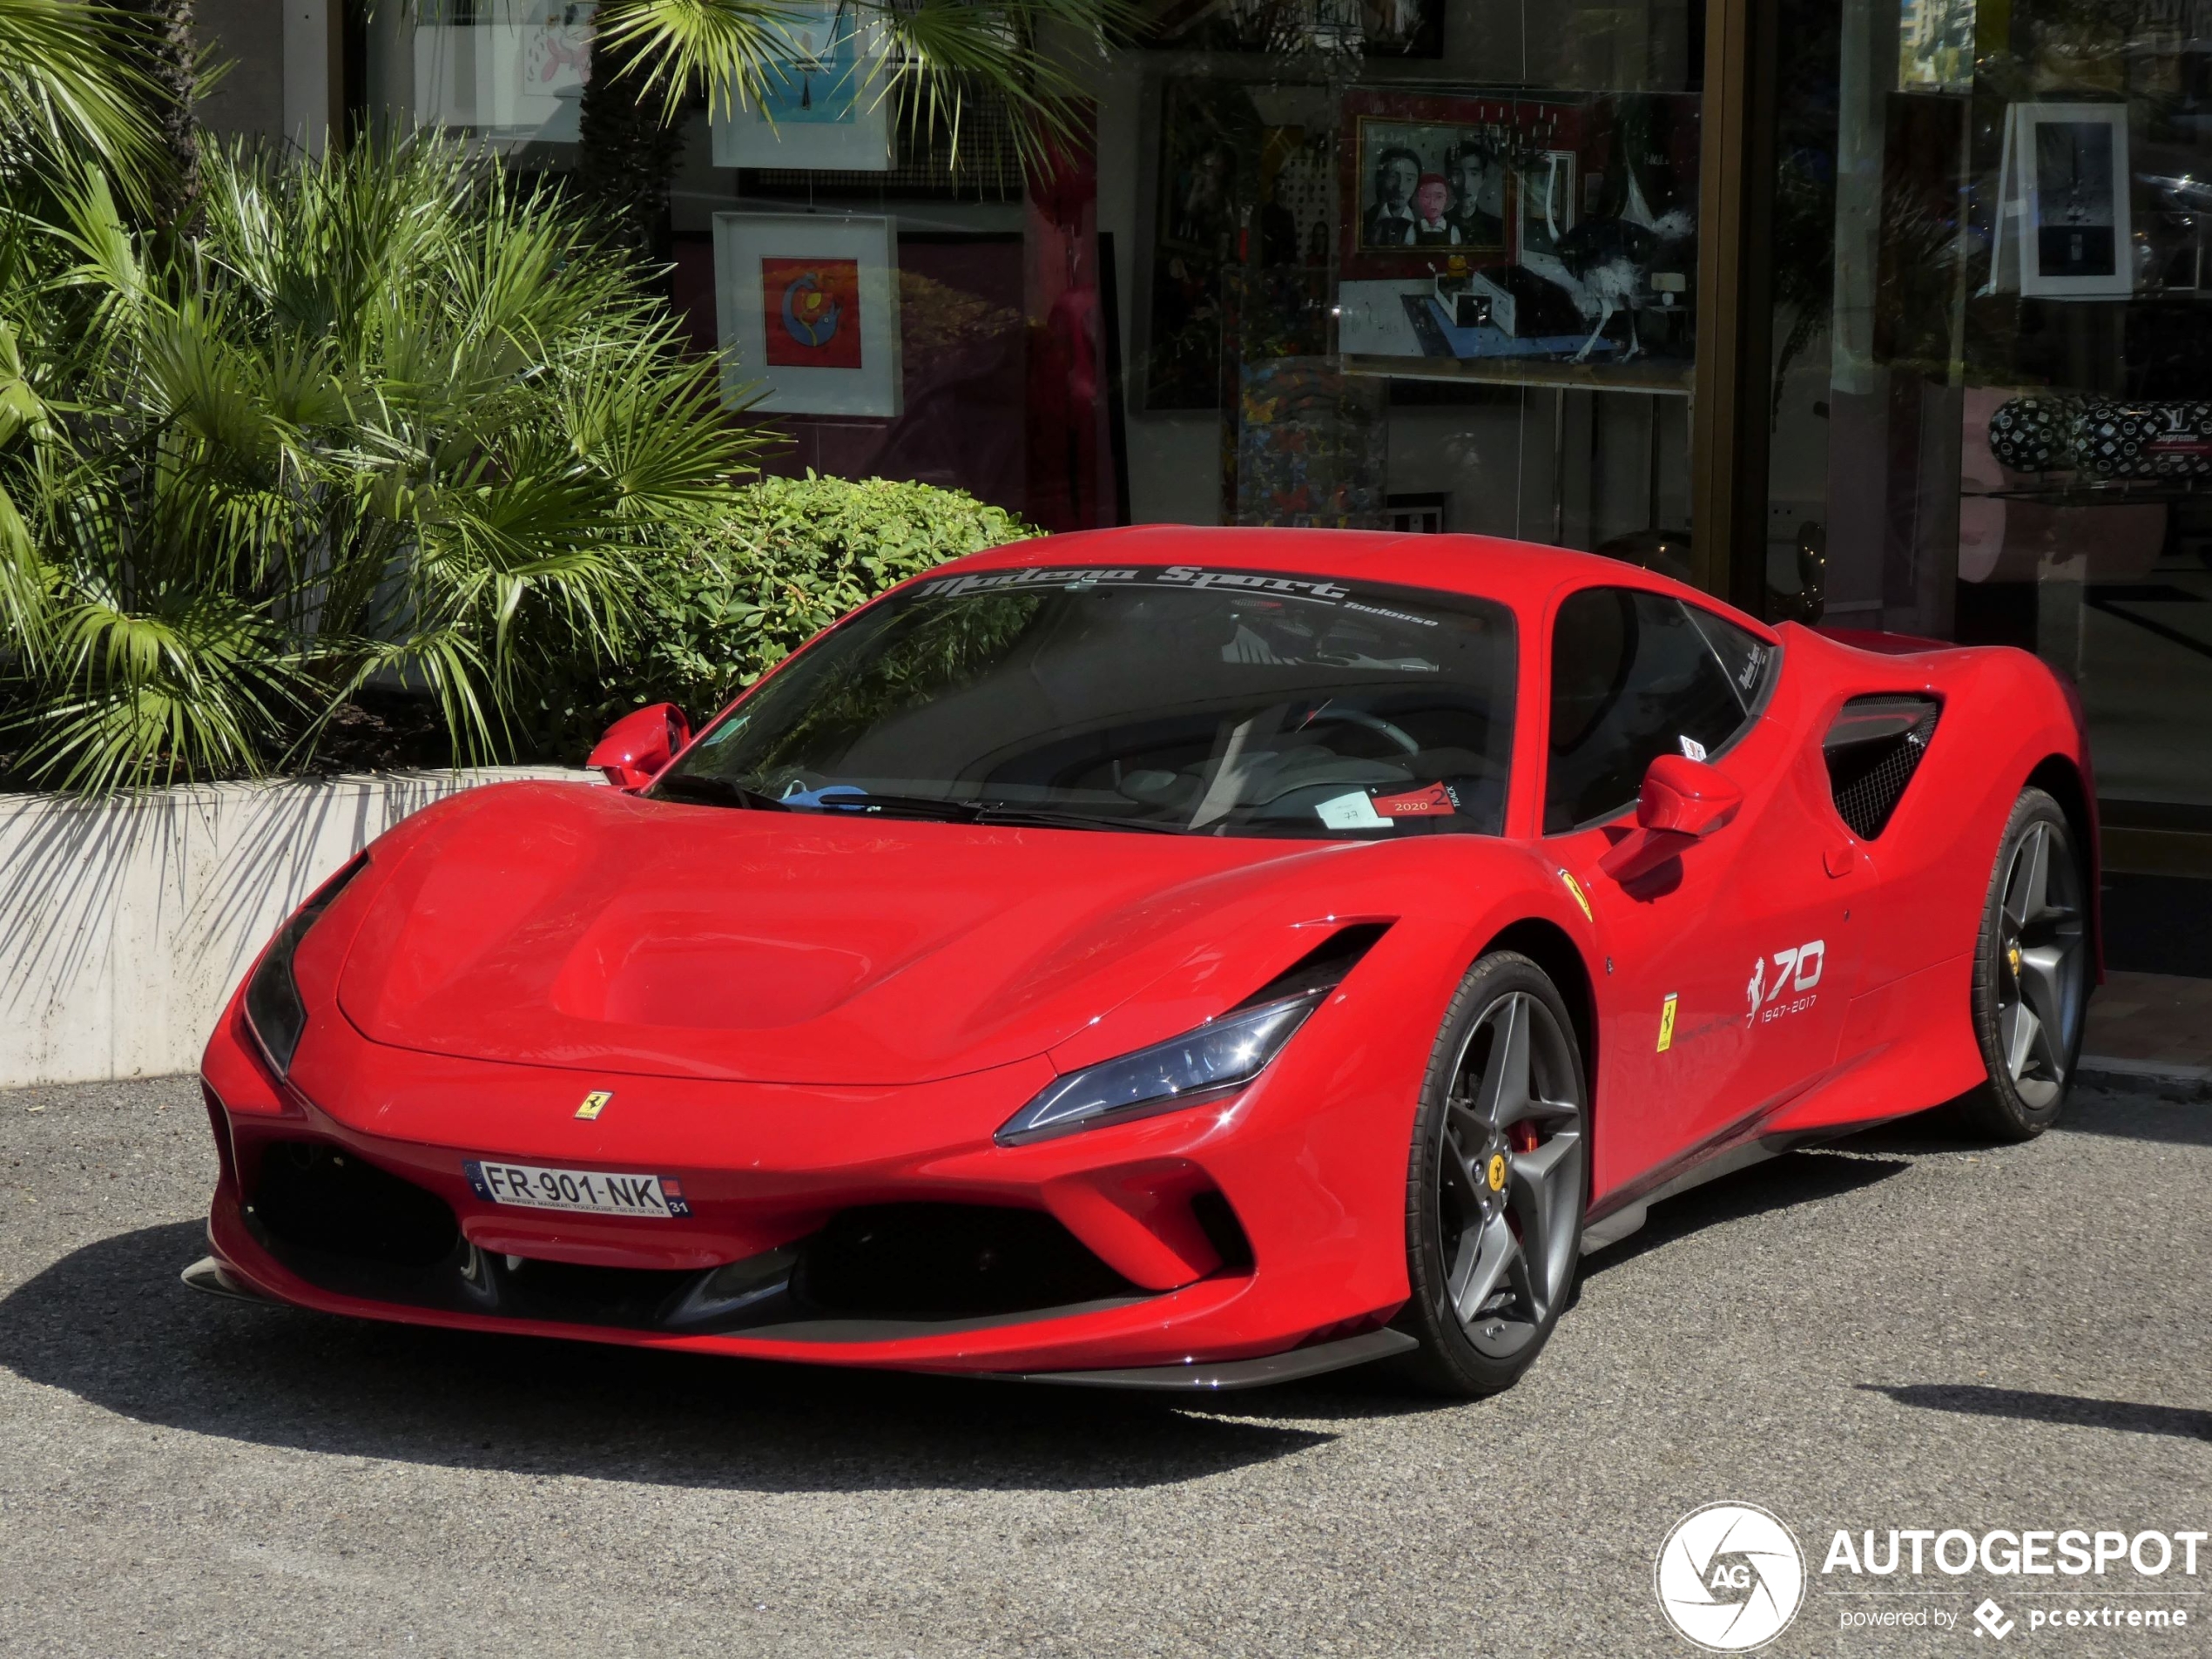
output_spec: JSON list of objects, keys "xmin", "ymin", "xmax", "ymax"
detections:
[{"xmin": 714, "ymin": 212, "xmax": 900, "ymax": 421}]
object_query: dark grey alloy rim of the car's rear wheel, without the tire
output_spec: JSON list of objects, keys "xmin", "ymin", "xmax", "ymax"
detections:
[{"xmin": 1998, "ymin": 823, "xmax": 2084, "ymax": 1110}]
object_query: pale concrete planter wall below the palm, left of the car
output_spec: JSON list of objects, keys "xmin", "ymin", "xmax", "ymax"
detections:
[{"xmin": 0, "ymin": 767, "xmax": 597, "ymax": 1089}]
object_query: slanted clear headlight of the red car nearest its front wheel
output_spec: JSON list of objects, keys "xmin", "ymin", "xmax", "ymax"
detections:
[{"xmin": 998, "ymin": 988, "xmax": 1327, "ymax": 1146}]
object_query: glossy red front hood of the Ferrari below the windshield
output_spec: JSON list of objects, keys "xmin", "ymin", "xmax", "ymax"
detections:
[{"xmin": 329, "ymin": 783, "xmax": 1365, "ymax": 1084}]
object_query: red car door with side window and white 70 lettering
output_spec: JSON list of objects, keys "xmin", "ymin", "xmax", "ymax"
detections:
[{"xmin": 1541, "ymin": 586, "xmax": 1867, "ymax": 1192}]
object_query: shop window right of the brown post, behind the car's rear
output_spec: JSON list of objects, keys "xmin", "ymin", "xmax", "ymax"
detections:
[{"xmin": 1765, "ymin": 0, "xmax": 2212, "ymax": 827}]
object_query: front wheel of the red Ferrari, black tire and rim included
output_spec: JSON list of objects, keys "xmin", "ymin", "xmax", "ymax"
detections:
[{"xmin": 1393, "ymin": 951, "xmax": 1590, "ymax": 1398}]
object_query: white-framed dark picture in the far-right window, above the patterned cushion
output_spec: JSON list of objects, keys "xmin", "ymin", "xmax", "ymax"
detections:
[{"xmin": 1998, "ymin": 104, "xmax": 2134, "ymax": 299}]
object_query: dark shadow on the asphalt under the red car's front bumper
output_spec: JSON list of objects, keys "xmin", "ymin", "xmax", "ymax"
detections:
[{"xmin": 0, "ymin": 1224, "xmax": 1334, "ymax": 1491}]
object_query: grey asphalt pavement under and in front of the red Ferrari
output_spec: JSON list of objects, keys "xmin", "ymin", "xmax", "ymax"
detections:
[{"xmin": 0, "ymin": 1077, "xmax": 2212, "ymax": 1659}]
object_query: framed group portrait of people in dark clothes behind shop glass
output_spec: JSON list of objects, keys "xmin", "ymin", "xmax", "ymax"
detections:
[{"xmin": 1339, "ymin": 93, "xmax": 1573, "ymax": 279}]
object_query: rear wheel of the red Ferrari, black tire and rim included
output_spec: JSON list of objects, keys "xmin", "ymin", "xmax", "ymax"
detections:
[{"xmin": 1958, "ymin": 790, "xmax": 2090, "ymax": 1142}]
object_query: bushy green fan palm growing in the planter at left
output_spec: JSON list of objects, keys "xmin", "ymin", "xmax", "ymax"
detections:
[{"xmin": 0, "ymin": 144, "xmax": 759, "ymax": 790}]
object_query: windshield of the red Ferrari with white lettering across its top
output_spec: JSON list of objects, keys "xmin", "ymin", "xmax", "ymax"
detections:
[{"xmin": 651, "ymin": 564, "xmax": 1513, "ymax": 839}]
